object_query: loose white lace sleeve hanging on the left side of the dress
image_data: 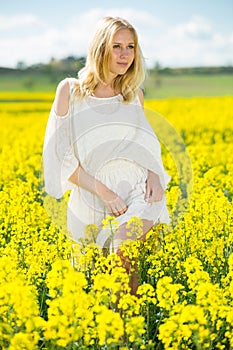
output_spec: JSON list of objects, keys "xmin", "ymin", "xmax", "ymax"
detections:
[{"xmin": 43, "ymin": 80, "xmax": 79, "ymax": 199}]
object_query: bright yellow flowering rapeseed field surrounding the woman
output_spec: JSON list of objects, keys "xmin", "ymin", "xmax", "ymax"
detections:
[{"xmin": 0, "ymin": 93, "xmax": 233, "ymax": 350}]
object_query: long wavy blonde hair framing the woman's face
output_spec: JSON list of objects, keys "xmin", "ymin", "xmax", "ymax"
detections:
[{"xmin": 74, "ymin": 17, "xmax": 145, "ymax": 103}]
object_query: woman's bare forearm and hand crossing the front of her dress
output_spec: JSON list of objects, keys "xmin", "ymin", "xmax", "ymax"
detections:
[{"xmin": 69, "ymin": 166, "xmax": 128, "ymax": 216}]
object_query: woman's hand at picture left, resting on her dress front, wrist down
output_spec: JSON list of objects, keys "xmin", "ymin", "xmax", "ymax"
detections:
[{"xmin": 98, "ymin": 186, "xmax": 128, "ymax": 216}]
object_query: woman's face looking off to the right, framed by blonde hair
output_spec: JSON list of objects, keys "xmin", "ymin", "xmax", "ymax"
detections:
[{"xmin": 110, "ymin": 29, "xmax": 135, "ymax": 78}]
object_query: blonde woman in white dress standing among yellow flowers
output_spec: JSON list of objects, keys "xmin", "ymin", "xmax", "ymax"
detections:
[{"xmin": 43, "ymin": 17, "xmax": 169, "ymax": 266}]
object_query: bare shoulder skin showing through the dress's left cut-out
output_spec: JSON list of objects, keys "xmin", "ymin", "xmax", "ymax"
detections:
[{"xmin": 54, "ymin": 78, "xmax": 70, "ymax": 117}]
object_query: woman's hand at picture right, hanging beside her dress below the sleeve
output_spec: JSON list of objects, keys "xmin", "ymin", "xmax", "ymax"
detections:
[{"xmin": 145, "ymin": 170, "xmax": 164, "ymax": 203}]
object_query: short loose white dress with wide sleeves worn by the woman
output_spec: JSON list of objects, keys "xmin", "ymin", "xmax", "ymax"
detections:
[{"xmin": 43, "ymin": 78, "xmax": 170, "ymax": 246}]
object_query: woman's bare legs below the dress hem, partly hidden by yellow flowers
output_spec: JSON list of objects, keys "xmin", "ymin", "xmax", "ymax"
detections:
[{"xmin": 115, "ymin": 219, "xmax": 153, "ymax": 295}]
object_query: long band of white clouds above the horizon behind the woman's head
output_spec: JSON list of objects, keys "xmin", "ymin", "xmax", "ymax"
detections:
[{"xmin": 0, "ymin": 8, "xmax": 233, "ymax": 67}]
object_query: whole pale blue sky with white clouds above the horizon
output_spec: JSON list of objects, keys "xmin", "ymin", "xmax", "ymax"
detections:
[{"xmin": 0, "ymin": 0, "xmax": 233, "ymax": 67}]
